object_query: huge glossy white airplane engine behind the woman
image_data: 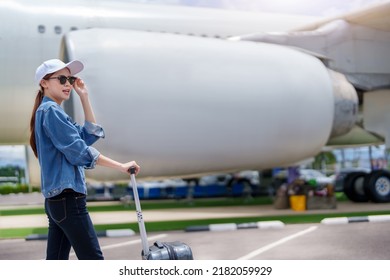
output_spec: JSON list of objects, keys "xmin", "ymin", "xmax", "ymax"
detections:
[{"xmin": 61, "ymin": 29, "xmax": 351, "ymax": 180}]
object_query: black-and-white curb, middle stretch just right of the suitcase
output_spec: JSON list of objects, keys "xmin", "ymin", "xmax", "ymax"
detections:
[{"xmin": 185, "ymin": 221, "xmax": 284, "ymax": 232}]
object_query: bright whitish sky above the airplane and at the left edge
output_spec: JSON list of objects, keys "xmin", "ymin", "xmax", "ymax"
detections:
[{"xmin": 0, "ymin": 0, "xmax": 388, "ymax": 167}]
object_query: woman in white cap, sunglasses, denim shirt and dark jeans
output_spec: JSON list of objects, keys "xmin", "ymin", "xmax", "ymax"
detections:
[{"xmin": 30, "ymin": 59, "xmax": 140, "ymax": 260}]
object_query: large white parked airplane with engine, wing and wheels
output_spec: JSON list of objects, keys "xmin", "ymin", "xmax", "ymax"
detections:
[{"xmin": 0, "ymin": 0, "xmax": 390, "ymax": 202}]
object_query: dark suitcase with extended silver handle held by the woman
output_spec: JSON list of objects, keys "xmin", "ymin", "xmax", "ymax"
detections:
[{"xmin": 129, "ymin": 167, "xmax": 194, "ymax": 260}]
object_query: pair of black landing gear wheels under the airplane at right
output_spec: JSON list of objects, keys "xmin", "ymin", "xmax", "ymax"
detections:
[{"xmin": 344, "ymin": 170, "xmax": 390, "ymax": 202}]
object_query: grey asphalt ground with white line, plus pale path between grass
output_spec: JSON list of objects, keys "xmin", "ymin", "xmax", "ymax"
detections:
[{"xmin": 0, "ymin": 193, "xmax": 390, "ymax": 260}]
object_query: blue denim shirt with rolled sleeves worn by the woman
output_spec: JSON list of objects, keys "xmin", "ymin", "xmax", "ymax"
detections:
[{"xmin": 35, "ymin": 96, "xmax": 104, "ymax": 198}]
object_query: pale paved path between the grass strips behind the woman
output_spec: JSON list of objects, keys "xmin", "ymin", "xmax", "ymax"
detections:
[{"xmin": 0, "ymin": 193, "xmax": 390, "ymax": 229}]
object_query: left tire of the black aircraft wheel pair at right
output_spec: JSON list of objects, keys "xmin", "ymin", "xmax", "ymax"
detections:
[{"xmin": 344, "ymin": 172, "xmax": 369, "ymax": 202}]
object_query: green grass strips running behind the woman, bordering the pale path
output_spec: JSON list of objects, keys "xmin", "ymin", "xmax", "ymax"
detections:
[{"xmin": 0, "ymin": 194, "xmax": 390, "ymax": 238}]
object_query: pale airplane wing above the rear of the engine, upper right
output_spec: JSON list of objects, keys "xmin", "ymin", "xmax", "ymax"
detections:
[{"xmin": 231, "ymin": 2, "xmax": 390, "ymax": 91}]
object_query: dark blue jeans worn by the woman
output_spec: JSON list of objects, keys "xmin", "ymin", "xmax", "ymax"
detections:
[{"xmin": 45, "ymin": 189, "xmax": 104, "ymax": 260}]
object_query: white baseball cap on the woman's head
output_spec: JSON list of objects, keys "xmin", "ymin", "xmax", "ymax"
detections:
[{"xmin": 35, "ymin": 59, "xmax": 84, "ymax": 85}]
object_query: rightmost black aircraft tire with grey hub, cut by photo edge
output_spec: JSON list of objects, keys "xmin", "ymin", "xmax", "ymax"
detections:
[{"xmin": 364, "ymin": 170, "xmax": 390, "ymax": 203}]
